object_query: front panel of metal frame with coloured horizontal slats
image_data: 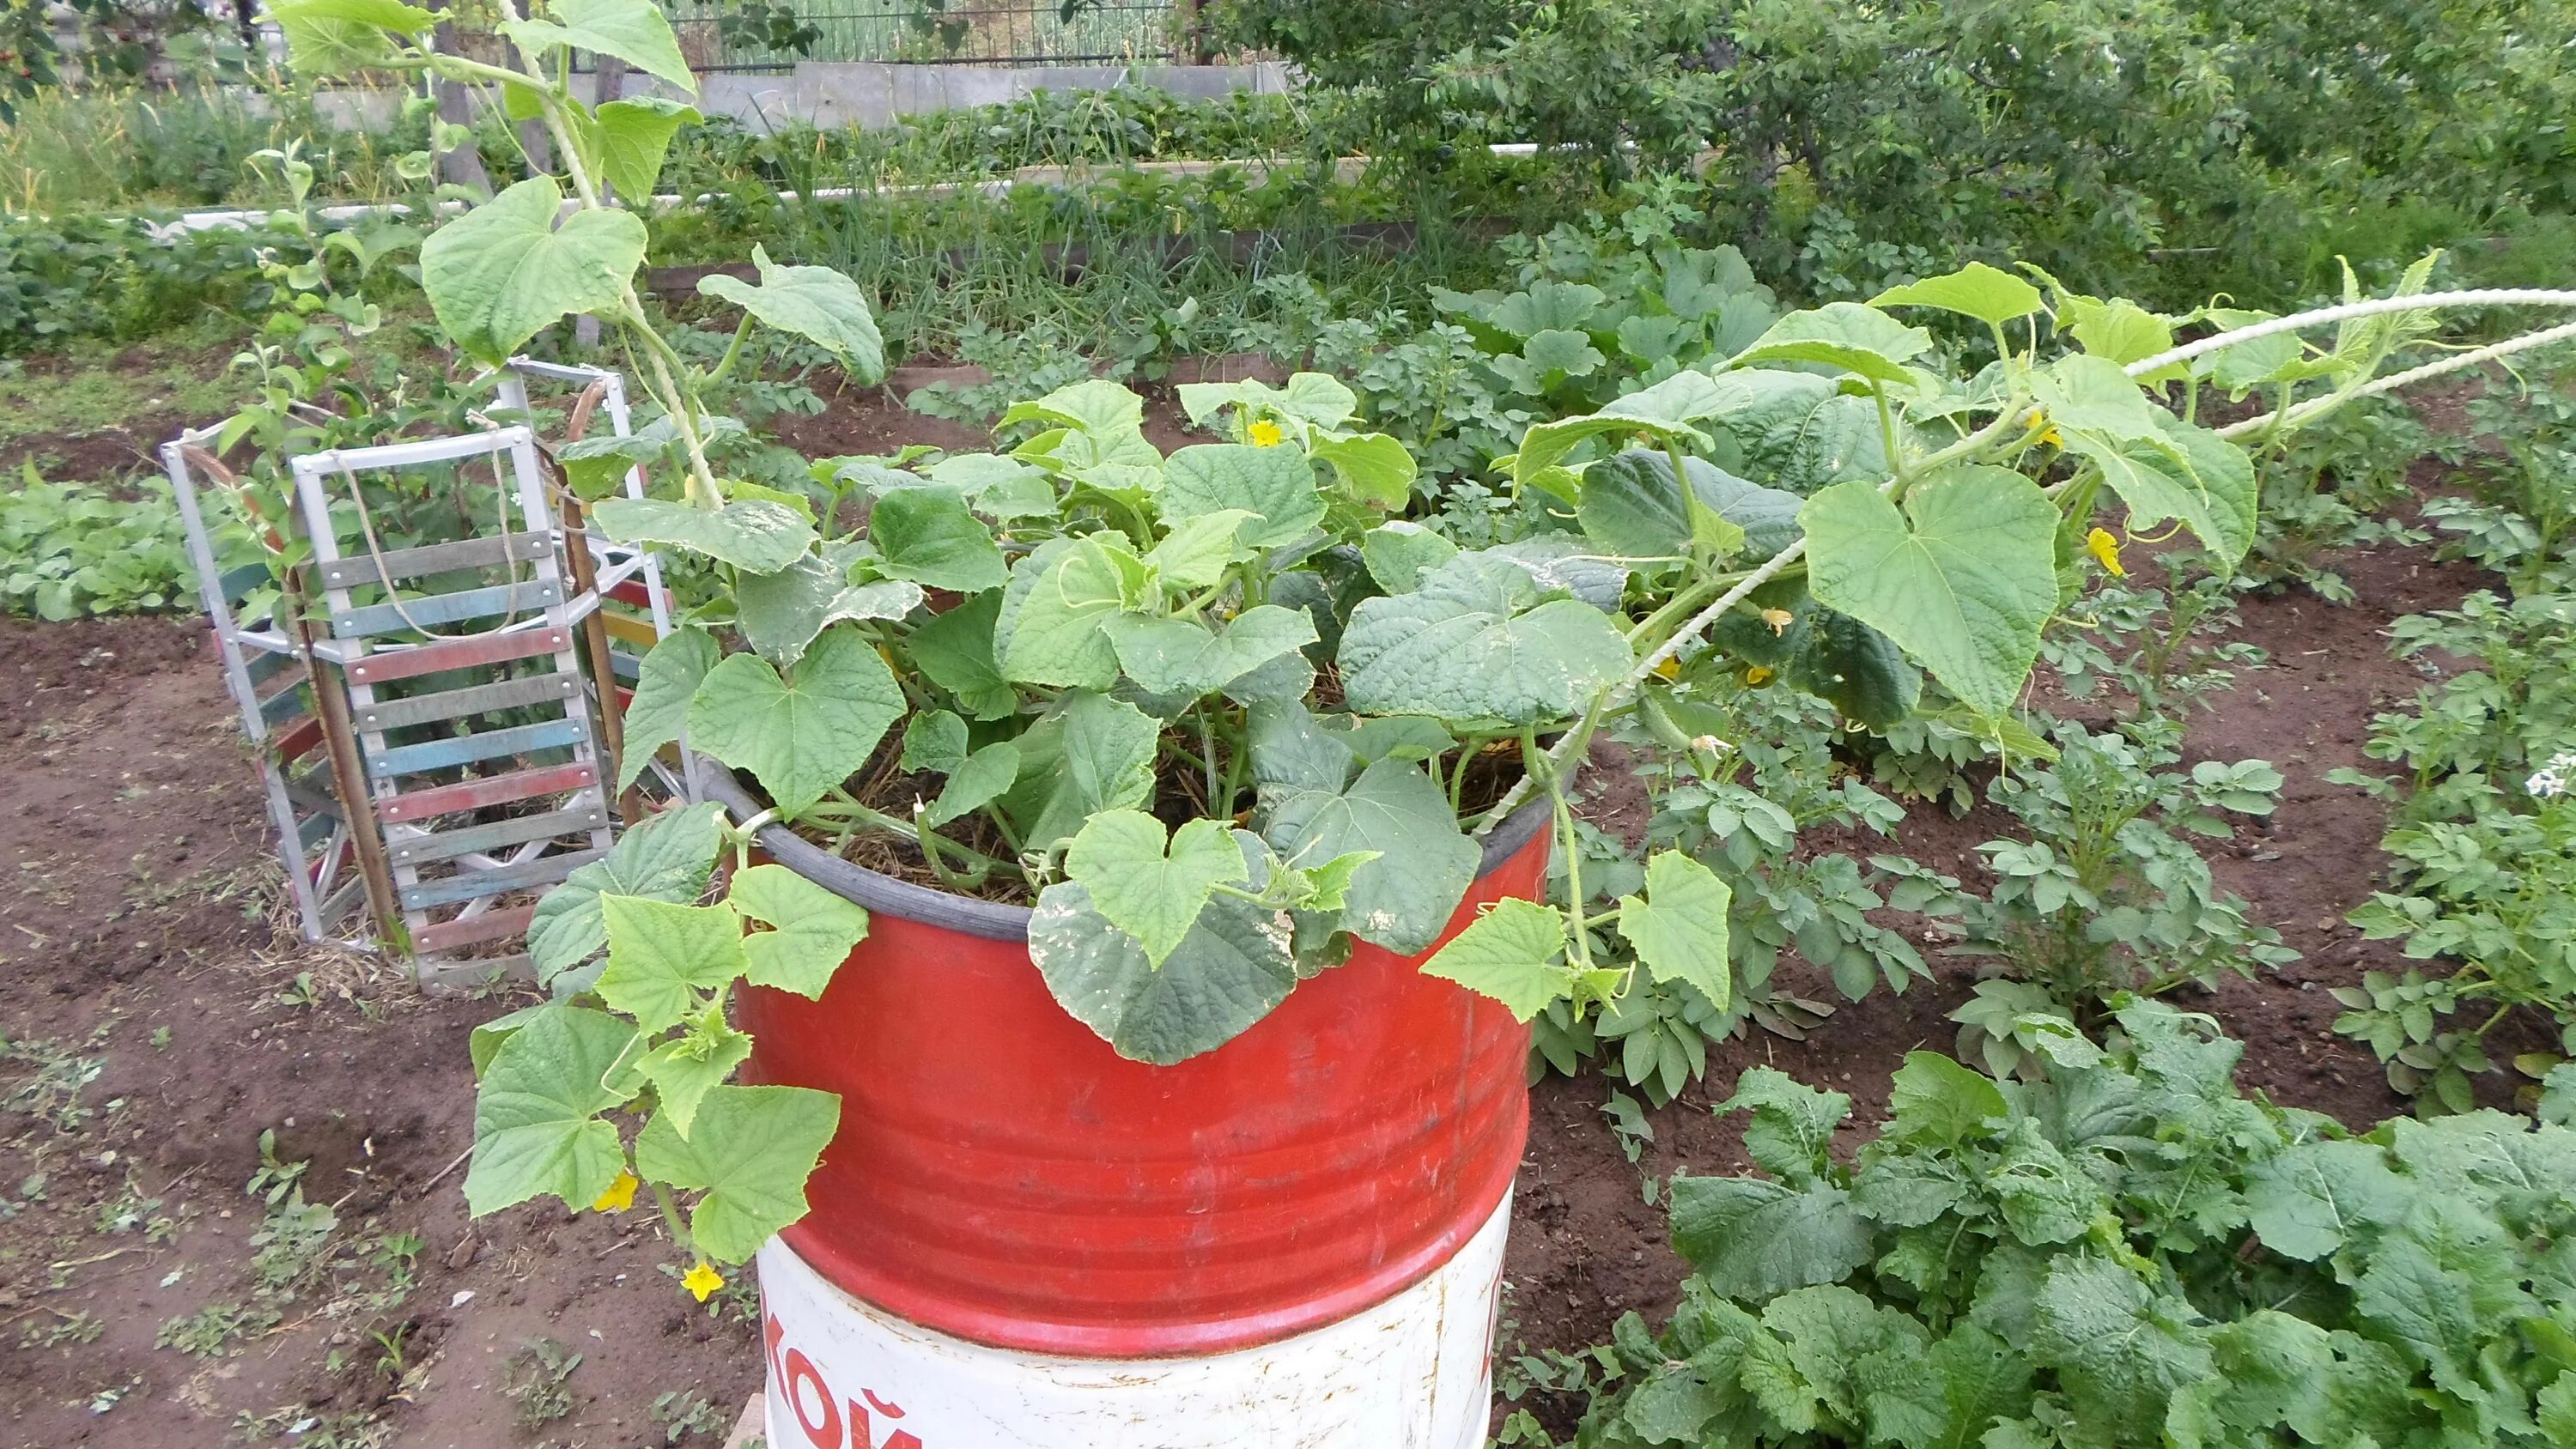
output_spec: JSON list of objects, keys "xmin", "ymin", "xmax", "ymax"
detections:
[{"xmin": 291, "ymin": 425, "xmax": 611, "ymax": 980}]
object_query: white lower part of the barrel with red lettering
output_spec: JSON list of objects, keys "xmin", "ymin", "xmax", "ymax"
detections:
[{"xmin": 760, "ymin": 1197, "xmax": 1512, "ymax": 1449}]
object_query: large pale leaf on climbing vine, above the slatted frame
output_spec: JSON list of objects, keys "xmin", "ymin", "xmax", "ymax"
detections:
[{"xmin": 420, "ymin": 175, "xmax": 644, "ymax": 366}]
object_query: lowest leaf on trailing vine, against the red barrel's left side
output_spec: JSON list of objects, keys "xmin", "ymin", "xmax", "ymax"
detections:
[{"xmin": 636, "ymin": 1086, "xmax": 840, "ymax": 1264}]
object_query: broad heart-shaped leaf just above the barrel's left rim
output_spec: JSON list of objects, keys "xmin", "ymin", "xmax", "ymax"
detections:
[{"xmin": 688, "ymin": 628, "xmax": 907, "ymax": 815}]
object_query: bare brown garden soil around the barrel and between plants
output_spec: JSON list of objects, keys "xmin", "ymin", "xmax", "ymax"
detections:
[{"xmin": 0, "ymin": 389, "xmax": 2504, "ymax": 1444}]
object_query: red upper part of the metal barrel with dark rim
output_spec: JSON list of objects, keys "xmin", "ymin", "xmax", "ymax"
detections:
[{"xmin": 737, "ymin": 787, "xmax": 1548, "ymax": 1359}]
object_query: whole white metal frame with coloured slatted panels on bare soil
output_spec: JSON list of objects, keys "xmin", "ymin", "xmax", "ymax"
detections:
[{"xmin": 162, "ymin": 358, "xmax": 693, "ymax": 980}]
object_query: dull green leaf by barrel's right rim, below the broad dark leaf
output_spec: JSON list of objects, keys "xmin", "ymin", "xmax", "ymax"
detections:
[{"xmin": 1255, "ymin": 746, "xmax": 1484, "ymax": 955}]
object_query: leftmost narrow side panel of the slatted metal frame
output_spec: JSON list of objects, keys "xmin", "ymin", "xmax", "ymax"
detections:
[{"xmin": 160, "ymin": 427, "xmax": 374, "ymax": 949}]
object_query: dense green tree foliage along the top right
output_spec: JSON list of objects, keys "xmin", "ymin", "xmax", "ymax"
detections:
[{"xmin": 1218, "ymin": 0, "xmax": 2576, "ymax": 286}]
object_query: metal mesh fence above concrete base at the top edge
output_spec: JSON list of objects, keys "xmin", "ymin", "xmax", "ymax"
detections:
[{"xmin": 670, "ymin": 0, "xmax": 1193, "ymax": 72}]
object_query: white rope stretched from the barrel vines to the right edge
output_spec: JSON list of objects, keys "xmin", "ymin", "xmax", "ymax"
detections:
[{"xmin": 1473, "ymin": 286, "xmax": 2576, "ymax": 836}]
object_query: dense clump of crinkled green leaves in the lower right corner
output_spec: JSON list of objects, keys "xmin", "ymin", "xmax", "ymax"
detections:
[{"xmin": 1502, "ymin": 1001, "xmax": 2576, "ymax": 1449}]
